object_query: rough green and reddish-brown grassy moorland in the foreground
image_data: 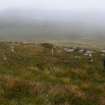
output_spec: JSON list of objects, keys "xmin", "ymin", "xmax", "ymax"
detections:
[{"xmin": 0, "ymin": 42, "xmax": 105, "ymax": 105}]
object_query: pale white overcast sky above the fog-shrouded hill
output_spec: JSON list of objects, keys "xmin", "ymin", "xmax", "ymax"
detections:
[{"xmin": 0, "ymin": 0, "xmax": 105, "ymax": 11}]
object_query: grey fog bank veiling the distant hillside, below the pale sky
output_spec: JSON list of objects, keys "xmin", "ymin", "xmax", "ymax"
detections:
[{"xmin": 0, "ymin": 8, "xmax": 105, "ymax": 42}]
